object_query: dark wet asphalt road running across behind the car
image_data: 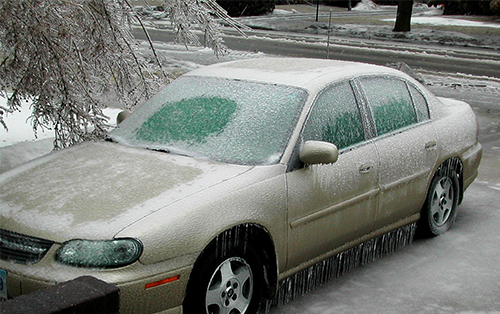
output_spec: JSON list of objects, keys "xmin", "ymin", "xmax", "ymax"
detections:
[{"xmin": 134, "ymin": 25, "xmax": 500, "ymax": 78}]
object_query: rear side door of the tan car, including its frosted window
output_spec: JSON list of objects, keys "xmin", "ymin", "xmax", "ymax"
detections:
[{"xmin": 359, "ymin": 76, "xmax": 437, "ymax": 229}]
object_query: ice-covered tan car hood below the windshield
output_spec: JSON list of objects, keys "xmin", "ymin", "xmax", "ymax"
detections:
[{"xmin": 0, "ymin": 142, "xmax": 251, "ymax": 242}]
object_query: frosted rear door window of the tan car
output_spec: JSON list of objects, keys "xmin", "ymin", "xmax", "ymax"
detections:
[{"xmin": 360, "ymin": 77, "xmax": 417, "ymax": 135}]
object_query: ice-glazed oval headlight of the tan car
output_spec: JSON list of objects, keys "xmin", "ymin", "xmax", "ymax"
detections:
[{"xmin": 56, "ymin": 238, "xmax": 142, "ymax": 268}]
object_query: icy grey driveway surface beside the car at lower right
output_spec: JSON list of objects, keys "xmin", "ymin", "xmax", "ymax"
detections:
[{"xmin": 270, "ymin": 180, "xmax": 500, "ymax": 314}]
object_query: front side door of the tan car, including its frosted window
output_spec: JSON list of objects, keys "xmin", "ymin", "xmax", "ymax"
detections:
[{"xmin": 286, "ymin": 82, "xmax": 378, "ymax": 268}]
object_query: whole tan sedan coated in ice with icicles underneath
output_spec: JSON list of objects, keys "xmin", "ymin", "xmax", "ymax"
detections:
[{"xmin": 0, "ymin": 58, "xmax": 482, "ymax": 314}]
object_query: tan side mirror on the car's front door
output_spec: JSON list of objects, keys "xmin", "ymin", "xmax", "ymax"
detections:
[{"xmin": 299, "ymin": 141, "xmax": 339, "ymax": 165}]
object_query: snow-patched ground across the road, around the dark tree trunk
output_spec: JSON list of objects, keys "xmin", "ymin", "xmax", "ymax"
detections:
[{"xmin": 234, "ymin": 0, "xmax": 500, "ymax": 50}]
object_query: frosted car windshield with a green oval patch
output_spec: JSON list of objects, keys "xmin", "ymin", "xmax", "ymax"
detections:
[{"xmin": 110, "ymin": 76, "xmax": 307, "ymax": 165}]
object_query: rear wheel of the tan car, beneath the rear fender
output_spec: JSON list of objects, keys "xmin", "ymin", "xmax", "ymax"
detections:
[{"xmin": 417, "ymin": 167, "xmax": 459, "ymax": 237}]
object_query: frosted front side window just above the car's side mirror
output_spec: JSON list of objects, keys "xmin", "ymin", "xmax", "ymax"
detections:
[{"xmin": 303, "ymin": 82, "xmax": 365, "ymax": 149}]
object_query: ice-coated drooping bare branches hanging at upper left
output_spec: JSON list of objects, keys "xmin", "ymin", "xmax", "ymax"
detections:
[{"xmin": 0, "ymin": 0, "xmax": 242, "ymax": 149}]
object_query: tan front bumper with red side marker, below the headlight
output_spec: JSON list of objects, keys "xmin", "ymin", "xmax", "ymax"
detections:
[{"xmin": 0, "ymin": 244, "xmax": 195, "ymax": 314}]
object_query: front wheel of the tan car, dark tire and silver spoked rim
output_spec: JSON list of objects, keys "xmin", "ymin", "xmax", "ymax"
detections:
[{"xmin": 183, "ymin": 239, "xmax": 263, "ymax": 314}]
